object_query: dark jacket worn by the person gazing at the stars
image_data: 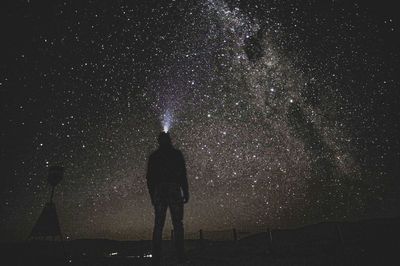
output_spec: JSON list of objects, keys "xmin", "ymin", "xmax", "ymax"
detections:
[{"xmin": 146, "ymin": 146, "xmax": 189, "ymax": 204}]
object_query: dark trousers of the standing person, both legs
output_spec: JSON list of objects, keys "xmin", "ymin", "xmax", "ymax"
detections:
[{"xmin": 153, "ymin": 202, "xmax": 184, "ymax": 265}]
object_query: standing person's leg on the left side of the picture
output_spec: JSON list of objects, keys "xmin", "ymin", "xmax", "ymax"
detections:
[{"xmin": 152, "ymin": 203, "xmax": 168, "ymax": 265}]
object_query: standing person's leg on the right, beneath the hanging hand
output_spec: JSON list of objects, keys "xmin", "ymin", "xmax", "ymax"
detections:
[{"xmin": 170, "ymin": 203, "xmax": 184, "ymax": 261}]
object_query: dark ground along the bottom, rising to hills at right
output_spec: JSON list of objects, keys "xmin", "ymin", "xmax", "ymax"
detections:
[{"xmin": 0, "ymin": 217, "xmax": 400, "ymax": 266}]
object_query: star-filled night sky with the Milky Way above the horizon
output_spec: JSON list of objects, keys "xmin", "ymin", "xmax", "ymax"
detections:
[{"xmin": 0, "ymin": 0, "xmax": 400, "ymax": 241}]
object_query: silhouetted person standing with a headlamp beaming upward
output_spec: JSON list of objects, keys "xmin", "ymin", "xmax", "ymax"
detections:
[{"xmin": 146, "ymin": 132, "xmax": 189, "ymax": 265}]
